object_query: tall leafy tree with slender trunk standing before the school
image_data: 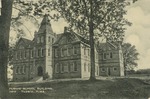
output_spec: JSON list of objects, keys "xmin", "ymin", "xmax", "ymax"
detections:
[{"xmin": 14, "ymin": 0, "xmax": 137, "ymax": 80}]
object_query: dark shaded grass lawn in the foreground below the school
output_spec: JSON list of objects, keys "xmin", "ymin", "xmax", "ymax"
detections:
[{"xmin": 10, "ymin": 78, "xmax": 150, "ymax": 99}]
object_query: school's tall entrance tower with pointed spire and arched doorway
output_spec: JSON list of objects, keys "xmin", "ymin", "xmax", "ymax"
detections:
[{"xmin": 34, "ymin": 14, "xmax": 56, "ymax": 78}]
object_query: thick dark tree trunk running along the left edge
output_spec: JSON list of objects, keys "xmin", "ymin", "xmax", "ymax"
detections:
[{"xmin": 0, "ymin": 0, "xmax": 13, "ymax": 99}]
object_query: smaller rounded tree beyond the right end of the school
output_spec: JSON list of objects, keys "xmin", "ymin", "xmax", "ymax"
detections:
[{"xmin": 122, "ymin": 43, "xmax": 139, "ymax": 75}]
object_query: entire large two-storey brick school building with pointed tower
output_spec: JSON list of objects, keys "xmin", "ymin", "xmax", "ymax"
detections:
[{"xmin": 12, "ymin": 15, "xmax": 124, "ymax": 81}]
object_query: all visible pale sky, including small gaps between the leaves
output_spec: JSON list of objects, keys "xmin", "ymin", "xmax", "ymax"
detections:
[{"xmin": 11, "ymin": 0, "xmax": 150, "ymax": 69}]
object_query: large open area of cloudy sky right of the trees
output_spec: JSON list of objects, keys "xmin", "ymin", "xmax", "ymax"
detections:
[{"xmin": 125, "ymin": 0, "xmax": 150, "ymax": 69}]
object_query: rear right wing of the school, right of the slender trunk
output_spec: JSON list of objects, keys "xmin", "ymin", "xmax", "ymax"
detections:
[{"xmin": 99, "ymin": 42, "xmax": 124, "ymax": 76}]
